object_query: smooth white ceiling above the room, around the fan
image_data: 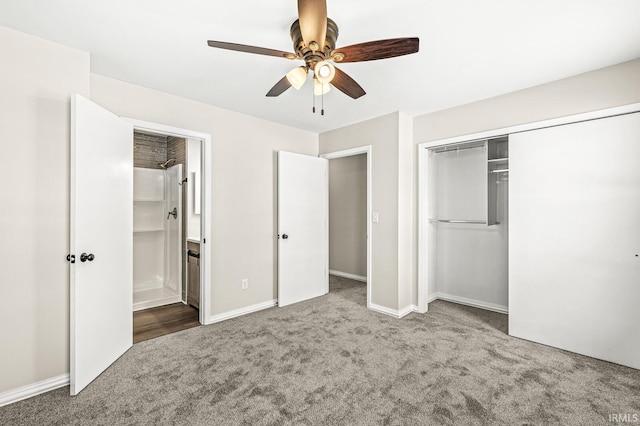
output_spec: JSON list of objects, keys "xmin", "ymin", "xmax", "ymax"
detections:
[{"xmin": 0, "ymin": 0, "xmax": 640, "ymax": 132}]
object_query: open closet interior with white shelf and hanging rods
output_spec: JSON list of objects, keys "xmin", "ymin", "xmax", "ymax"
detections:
[{"xmin": 427, "ymin": 136, "xmax": 509, "ymax": 312}]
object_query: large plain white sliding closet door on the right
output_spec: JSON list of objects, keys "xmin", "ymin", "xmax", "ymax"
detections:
[{"xmin": 509, "ymin": 113, "xmax": 640, "ymax": 368}]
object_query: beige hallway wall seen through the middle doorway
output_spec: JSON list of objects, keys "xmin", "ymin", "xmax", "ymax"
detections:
[{"xmin": 329, "ymin": 154, "xmax": 367, "ymax": 277}]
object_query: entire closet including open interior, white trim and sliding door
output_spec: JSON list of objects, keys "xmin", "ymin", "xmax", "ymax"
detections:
[{"xmin": 418, "ymin": 104, "xmax": 640, "ymax": 369}]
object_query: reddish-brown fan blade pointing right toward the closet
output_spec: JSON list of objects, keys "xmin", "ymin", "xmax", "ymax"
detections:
[{"xmin": 331, "ymin": 37, "xmax": 420, "ymax": 63}]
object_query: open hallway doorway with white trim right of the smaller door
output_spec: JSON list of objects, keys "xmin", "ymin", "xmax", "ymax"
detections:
[{"xmin": 320, "ymin": 145, "xmax": 372, "ymax": 308}]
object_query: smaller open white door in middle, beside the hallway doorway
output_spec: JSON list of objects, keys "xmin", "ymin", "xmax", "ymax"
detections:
[{"xmin": 278, "ymin": 151, "xmax": 329, "ymax": 306}]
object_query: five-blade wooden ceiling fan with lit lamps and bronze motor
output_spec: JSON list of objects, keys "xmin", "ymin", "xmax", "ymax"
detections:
[{"xmin": 208, "ymin": 0, "xmax": 419, "ymax": 99}]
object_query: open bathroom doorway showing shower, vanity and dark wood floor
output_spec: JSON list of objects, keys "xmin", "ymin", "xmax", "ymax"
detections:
[{"xmin": 127, "ymin": 123, "xmax": 210, "ymax": 343}]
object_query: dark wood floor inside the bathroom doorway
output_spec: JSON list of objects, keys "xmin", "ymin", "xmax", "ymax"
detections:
[{"xmin": 133, "ymin": 303, "xmax": 200, "ymax": 343}]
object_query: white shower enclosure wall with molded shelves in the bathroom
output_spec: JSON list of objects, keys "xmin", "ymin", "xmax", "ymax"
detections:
[{"xmin": 133, "ymin": 164, "xmax": 182, "ymax": 311}]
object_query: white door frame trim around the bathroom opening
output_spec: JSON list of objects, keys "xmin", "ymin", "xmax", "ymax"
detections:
[{"xmin": 122, "ymin": 117, "xmax": 212, "ymax": 325}]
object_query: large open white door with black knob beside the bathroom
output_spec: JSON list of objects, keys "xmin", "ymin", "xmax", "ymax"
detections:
[{"xmin": 70, "ymin": 95, "xmax": 133, "ymax": 395}]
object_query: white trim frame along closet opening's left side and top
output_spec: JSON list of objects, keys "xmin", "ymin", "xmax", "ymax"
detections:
[{"xmin": 417, "ymin": 103, "xmax": 640, "ymax": 314}]
